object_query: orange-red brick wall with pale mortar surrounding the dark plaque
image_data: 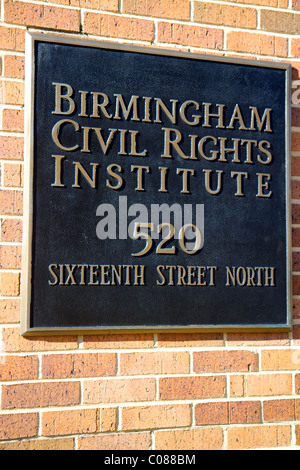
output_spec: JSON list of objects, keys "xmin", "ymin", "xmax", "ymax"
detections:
[{"xmin": 0, "ymin": 0, "xmax": 300, "ymax": 450}]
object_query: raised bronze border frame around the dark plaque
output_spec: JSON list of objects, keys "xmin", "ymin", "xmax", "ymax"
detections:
[{"xmin": 20, "ymin": 31, "xmax": 292, "ymax": 336}]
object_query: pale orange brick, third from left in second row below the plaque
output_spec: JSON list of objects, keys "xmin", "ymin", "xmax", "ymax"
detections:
[{"xmin": 120, "ymin": 352, "xmax": 190, "ymax": 375}]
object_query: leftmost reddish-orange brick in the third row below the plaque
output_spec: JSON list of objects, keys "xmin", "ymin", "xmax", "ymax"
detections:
[{"xmin": 2, "ymin": 381, "xmax": 80, "ymax": 410}]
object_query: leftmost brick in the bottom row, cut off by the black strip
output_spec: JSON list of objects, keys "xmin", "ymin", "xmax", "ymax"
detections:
[{"xmin": 0, "ymin": 438, "xmax": 74, "ymax": 451}]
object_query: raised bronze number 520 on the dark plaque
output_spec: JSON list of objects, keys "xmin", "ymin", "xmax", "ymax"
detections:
[{"xmin": 132, "ymin": 222, "xmax": 202, "ymax": 256}]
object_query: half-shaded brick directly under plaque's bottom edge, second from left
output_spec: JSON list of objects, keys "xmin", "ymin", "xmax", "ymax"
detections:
[{"xmin": 83, "ymin": 334, "xmax": 154, "ymax": 349}]
